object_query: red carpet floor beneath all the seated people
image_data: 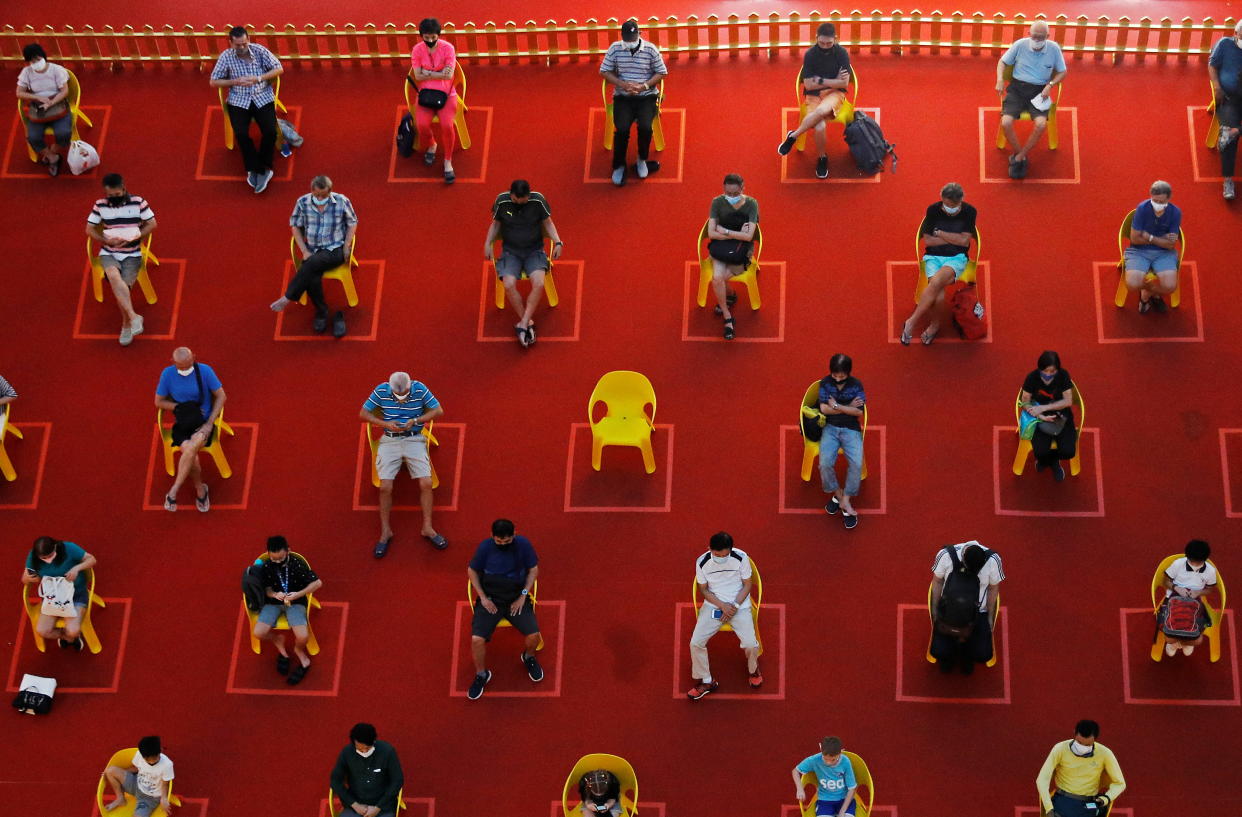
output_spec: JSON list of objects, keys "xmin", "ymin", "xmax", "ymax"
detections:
[{"xmin": 0, "ymin": 28, "xmax": 1242, "ymax": 817}]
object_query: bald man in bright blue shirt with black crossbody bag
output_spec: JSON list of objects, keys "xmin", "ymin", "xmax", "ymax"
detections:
[{"xmin": 155, "ymin": 346, "xmax": 225, "ymax": 513}]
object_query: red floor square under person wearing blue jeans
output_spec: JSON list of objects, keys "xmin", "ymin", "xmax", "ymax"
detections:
[{"xmin": 776, "ymin": 426, "xmax": 888, "ymax": 517}]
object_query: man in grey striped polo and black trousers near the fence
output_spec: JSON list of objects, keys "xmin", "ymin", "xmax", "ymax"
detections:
[{"xmin": 600, "ymin": 20, "xmax": 668, "ymax": 187}]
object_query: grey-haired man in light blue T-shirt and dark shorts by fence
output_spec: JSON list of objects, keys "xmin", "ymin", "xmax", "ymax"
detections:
[{"xmin": 996, "ymin": 20, "xmax": 1066, "ymax": 179}]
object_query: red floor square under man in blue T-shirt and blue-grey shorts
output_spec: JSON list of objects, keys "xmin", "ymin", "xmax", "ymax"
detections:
[{"xmin": 1092, "ymin": 261, "xmax": 1203, "ymax": 343}]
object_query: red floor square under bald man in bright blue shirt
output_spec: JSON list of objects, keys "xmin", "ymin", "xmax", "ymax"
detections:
[{"xmin": 143, "ymin": 421, "xmax": 258, "ymax": 506}]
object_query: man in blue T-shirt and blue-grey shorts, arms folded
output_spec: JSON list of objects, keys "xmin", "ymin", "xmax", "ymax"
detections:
[{"xmin": 1125, "ymin": 181, "xmax": 1181, "ymax": 313}]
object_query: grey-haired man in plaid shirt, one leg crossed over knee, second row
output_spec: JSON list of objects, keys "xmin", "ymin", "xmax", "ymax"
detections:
[{"xmin": 272, "ymin": 176, "xmax": 358, "ymax": 338}]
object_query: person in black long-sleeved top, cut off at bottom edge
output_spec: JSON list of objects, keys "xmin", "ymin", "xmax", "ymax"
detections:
[{"xmin": 330, "ymin": 724, "xmax": 405, "ymax": 817}]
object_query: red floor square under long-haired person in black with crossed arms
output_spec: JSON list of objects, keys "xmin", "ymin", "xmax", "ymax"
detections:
[{"xmin": 992, "ymin": 426, "xmax": 1104, "ymax": 517}]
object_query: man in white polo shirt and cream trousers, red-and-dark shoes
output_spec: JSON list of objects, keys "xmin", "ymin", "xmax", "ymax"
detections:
[{"xmin": 686, "ymin": 530, "xmax": 764, "ymax": 700}]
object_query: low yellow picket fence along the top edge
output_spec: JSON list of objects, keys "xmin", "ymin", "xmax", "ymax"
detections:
[{"xmin": 0, "ymin": 10, "xmax": 1233, "ymax": 65}]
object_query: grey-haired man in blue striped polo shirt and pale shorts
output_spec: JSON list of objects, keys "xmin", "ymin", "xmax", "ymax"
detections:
[{"xmin": 359, "ymin": 371, "xmax": 448, "ymax": 559}]
